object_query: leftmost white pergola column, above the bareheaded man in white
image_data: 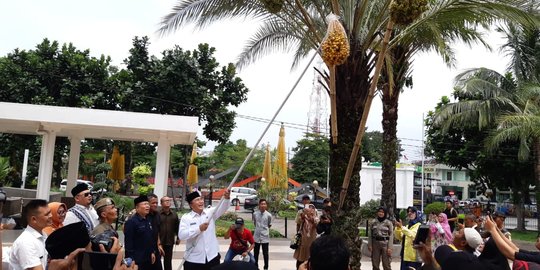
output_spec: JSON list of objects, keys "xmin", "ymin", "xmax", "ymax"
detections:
[{"xmin": 36, "ymin": 130, "xmax": 56, "ymax": 201}]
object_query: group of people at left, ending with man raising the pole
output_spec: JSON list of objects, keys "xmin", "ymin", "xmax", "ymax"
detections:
[{"xmin": 3, "ymin": 184, "xmax": 234, "ymax": 270}]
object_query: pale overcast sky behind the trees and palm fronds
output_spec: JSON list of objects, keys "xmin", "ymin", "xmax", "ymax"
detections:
[{"xmin": 0, "ymin": 0, "xmax": 507, "ymax": 159}]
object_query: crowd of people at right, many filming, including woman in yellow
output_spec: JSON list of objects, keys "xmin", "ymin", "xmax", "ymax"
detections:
[{"xmin": 368, "ymin": 198, "xmax": 540, "ymax": 270}]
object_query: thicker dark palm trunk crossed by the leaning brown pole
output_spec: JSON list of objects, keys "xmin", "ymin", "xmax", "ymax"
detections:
[{"xmin": 329, "ymin": 41, "xmax": 371, "ymax": 269}]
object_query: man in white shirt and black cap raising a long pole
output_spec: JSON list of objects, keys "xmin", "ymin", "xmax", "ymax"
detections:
[{"xmin": 178, "ymin": 190, "xmax": 230, "ymax": 270}]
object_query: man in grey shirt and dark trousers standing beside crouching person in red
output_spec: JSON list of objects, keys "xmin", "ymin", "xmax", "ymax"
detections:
[{"xmin": 253, "ymin": 199, "xmax": 272, "ymax": 270}]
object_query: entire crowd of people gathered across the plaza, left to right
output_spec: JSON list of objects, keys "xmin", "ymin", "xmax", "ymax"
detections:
[{"xmin": 8, "ymin": 184, "xmax": 540, "ymax": 270}]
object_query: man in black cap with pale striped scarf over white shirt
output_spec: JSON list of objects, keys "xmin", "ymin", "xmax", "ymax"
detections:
[{"xmin": 64, "ymin": 183, "xmax": 99, "ymax": 234}]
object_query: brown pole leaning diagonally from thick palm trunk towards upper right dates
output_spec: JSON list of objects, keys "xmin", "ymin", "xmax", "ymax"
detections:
[{"xmin": 338, "ymin": 19, "xmax": 394, "ymax": 211}]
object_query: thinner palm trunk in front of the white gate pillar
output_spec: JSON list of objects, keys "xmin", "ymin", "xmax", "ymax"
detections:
[{"xmin": 381, "ymin": 84, "xmax": 400, "ymax": 216}]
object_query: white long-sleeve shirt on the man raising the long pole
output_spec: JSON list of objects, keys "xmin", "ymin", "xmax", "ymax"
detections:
[{"xmin": 178, "ymin": 200, "xmax": 231, "ymax": 264}]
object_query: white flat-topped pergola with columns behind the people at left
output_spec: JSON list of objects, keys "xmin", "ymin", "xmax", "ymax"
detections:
[{"xmin": 0, "ymin": 102, "xmax": 198, "ymax": 200}]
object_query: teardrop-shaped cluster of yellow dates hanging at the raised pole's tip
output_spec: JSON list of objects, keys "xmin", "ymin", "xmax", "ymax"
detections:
[{"xmin": 321, "ymin": 14, "xmax": 350, "ymax": 66}]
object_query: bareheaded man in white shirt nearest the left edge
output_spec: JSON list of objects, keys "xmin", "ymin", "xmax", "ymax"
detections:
[{"xmin": 9, "ymin": 200, "xmax": 52, "ymax": 270}]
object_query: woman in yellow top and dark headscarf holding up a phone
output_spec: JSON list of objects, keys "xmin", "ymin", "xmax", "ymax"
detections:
[{"xmin": 394, "ymin": 206, "xmax": 422, "ymax": 270}]
